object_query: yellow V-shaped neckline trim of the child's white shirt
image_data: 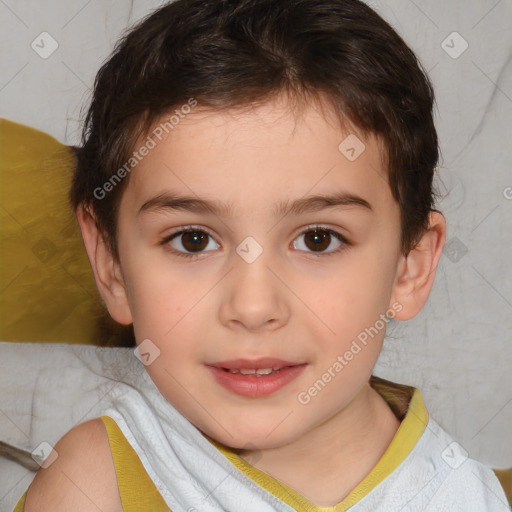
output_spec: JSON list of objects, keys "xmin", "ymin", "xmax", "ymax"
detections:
[{"xmin": 207, "ymin": 381, "xmax": 428, "ymax": 512}]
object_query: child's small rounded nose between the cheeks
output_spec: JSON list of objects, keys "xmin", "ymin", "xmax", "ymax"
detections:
[{"xmin": 219, "ymin": 244, "xmax": 290, "ymax": 332}]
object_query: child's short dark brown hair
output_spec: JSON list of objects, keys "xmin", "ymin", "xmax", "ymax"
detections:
[{"xmin": 70, "ymin": 0, "xmax": 438, "ymax": 260}]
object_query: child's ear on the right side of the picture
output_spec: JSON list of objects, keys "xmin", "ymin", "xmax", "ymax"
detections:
[{"xmin": 390, "ymin": 211, "xmax": 446, "ymax": 320}]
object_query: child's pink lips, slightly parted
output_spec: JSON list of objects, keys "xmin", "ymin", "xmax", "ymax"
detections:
[{"xmin": 206, "ymin": 358, "xmax": 307, "ymax": 398}]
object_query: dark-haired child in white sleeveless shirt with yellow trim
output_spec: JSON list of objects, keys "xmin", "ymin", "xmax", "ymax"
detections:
[{"xmin": 14, "ymin": 0, "xmax": 508, "ymax": 512}]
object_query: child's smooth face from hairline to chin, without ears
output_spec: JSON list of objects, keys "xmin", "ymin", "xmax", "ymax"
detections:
[{"xmin": 118, "ymin": 94, "xmax": 402, "ymax": 448}]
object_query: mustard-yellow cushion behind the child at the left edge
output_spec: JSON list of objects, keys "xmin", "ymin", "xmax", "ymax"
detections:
[{"xmin": 0, "ymin": 119, "xmax": 125, "ymax": 344}]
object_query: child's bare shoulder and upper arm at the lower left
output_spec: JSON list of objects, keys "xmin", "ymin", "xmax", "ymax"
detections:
[{"xmin": 25, "ymin": 418, "xmax": 123, "ymax": 512}]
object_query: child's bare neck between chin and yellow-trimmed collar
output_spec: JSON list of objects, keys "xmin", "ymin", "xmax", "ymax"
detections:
[{"xmin": 235, "ymin": 384, "xmax": 400, "ymax": 507}]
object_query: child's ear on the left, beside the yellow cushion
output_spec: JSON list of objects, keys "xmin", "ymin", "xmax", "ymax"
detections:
[{"xmin": 76, "ymin": 205, "xmax": 133, "ymax": 325}]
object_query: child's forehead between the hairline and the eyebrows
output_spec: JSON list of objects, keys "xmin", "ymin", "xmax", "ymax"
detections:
[{"xmin": 123, "ymin": 94, "xmax": 393, "ymax": 215}]
